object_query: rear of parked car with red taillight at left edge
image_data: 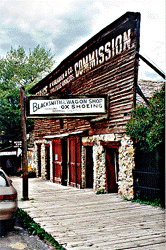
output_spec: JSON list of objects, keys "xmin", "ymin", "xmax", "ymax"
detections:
[{"xmin": 0, "ymin": 169, "xmax": 18, "ymax": 235}]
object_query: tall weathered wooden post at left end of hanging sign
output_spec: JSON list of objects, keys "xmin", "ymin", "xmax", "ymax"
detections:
[{"xmin": 20, "ymin": 87, "xmax": 29, "ymax": 200}]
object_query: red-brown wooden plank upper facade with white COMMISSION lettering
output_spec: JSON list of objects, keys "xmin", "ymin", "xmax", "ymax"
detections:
[{"xmin": 30, "ymin": 12, "xmax": 140, "ymax": 139}]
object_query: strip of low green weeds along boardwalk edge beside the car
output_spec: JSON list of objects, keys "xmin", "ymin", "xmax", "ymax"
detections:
[{"xmin": 17, "ymin": 209, "xmax": 64, "ymax": 250}]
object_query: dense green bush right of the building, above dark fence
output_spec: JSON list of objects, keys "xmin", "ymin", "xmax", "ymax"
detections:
[{"xmin": 126, "ymin": 86, "xmax": 165, "ymax": 152}]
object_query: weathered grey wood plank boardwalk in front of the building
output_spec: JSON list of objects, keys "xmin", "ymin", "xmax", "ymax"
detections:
[{"xmin": 13, "ymin": 177, "xmax": 165, "ymax": 250}]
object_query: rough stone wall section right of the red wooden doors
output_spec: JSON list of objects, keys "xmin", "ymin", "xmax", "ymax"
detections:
[{"xmin": 82, "ymin": 134, "xmax": 135, "ymax": 199}]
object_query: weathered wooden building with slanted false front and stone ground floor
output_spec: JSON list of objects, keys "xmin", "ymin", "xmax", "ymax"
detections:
[{"xmin": 28, "ymin": 12, "xmax": 160, "ymax": 199}]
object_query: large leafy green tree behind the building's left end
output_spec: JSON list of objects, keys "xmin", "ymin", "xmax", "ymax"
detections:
[{"xmin": 0, "ymin": 45, "xmax": 54, "ymax": 133}]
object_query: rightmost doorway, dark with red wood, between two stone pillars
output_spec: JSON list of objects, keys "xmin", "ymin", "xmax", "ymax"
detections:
[{"xmin": 105, "ymin": 148, "xmax": 119, "ymax": 193}]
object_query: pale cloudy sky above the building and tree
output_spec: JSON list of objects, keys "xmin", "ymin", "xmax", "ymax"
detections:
[{"xmin": 0, "ymin": 0, "xmax": 166, "ymax": 80}]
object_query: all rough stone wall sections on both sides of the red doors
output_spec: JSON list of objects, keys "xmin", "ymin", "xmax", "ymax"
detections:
[{"xmin": 33, "ymin": 134, "xmax": 135, "ymax": 199}]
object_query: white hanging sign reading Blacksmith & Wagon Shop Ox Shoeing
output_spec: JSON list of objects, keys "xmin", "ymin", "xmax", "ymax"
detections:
[{"xmin": 27, "ymin": 96, "xmax": 107, "ymax": 118}]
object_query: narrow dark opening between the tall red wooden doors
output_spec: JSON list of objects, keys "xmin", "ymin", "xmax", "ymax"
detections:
[{"xmin": 61, "ymin": 139, "xmax": 68, "ymax": 186}]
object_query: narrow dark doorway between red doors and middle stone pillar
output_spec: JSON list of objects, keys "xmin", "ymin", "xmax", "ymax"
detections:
[{"xmin": 85, "ymin": 146, "xmax": 94, "ymax": 188}]
